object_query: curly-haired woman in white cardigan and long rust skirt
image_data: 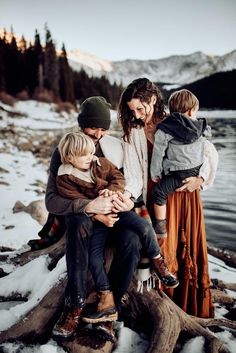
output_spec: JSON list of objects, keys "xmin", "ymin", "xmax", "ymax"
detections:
[{"xmin": 118, "ymin": 78, "xmax": 218, "ymax": 318}]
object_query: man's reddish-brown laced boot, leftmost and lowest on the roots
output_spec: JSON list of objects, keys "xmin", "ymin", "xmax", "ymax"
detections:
[{"xmin": 52, "ymin": 306, "xmax": 82, "ymax": 340}]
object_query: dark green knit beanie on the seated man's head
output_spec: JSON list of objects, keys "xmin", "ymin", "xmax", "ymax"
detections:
[{"xmin": 78, "ymin": 96, "xmax": 111, "ymax": 130}]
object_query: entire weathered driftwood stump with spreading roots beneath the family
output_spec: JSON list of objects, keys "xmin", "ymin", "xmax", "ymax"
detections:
[{"xmin": 0, "ymin": 237, "xmax": 236, "ymax": 353}]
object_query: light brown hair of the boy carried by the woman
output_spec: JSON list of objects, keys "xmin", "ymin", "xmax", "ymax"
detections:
[{"xmin": 168, "ymin": 89, "xmax": 199, "ymax": 114}]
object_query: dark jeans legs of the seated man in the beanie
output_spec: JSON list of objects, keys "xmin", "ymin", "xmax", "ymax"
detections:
[{"xmin": 65, "ymin": 214, "xmax": 141, "ymax": 307}]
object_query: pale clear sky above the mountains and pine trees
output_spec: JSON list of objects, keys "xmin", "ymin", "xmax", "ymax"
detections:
[{"xmin": 0, "ymin": 0, "xmax": 236, "ymax": 61}]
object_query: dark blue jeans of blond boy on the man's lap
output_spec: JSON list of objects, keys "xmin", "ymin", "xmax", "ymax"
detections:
[{"xmin": 89, "ymin": 211, "xmax": 160, "ymax": 295}]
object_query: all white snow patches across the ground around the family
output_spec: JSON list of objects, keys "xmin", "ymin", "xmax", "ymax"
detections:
[{"xmin": 0, "ymin": 101, "xmax": 236, "ymax": 353}]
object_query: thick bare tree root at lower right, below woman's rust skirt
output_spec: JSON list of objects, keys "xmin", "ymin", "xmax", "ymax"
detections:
[{"xmin": 121, "ymin": 282, "xmax": 233, "ymax": 353}]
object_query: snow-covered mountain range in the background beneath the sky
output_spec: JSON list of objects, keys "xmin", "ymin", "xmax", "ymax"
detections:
[{"xmin": 68, "ymin": 50, "xmax": 236, "ymax": 85}]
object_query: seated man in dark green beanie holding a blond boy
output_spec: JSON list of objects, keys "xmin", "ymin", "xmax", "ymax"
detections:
[{"xmin": 41, "ymin": 96, "xmax": 140, "ymax": 339}]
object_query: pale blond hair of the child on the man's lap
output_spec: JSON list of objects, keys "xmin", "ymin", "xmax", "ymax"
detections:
[{"xmin": 58, "ymin": 132, "xmax": 95, "ymax": 164}]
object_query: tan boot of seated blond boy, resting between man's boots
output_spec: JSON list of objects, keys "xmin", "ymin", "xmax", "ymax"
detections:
[{"xmin": 82, "ymin": 290, "xmax": 118, "ymax": 324}]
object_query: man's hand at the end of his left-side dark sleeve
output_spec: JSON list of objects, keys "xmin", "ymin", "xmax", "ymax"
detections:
[{"xmin": 84, "ymin": 195, "xmax": 116, "ymax": 214}]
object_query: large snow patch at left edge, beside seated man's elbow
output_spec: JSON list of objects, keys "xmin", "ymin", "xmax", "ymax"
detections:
[{"xmin": 0, "ymin": 151, "xmax": 47, "ymax": 249}]
